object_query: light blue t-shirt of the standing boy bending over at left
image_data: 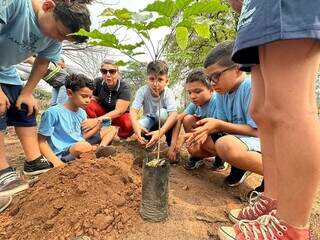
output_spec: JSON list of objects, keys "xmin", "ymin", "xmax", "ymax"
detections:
[{"xmin": 0, "ymin": 0, "xmax": 61, "ymax": 85}]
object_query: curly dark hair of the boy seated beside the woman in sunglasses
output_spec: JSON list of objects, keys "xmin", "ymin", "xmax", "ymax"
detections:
[{"xmin": 65, "ymin": 73, "xmax": 94, "ymax": 92}]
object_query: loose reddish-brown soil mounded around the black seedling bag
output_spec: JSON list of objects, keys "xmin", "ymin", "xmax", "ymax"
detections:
[{"xmin": 0, "ymin": 129, "xmax": 320, "ymax": 240}]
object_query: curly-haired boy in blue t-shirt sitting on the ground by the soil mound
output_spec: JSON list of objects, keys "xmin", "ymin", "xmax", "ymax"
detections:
[{"xmin": 38, "ymin": 74, "xmax": 117, "ymax": 167}]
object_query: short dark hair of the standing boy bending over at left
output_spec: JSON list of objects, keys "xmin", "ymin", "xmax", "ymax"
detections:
[{"xmin": 53, "ymin": 0, "xmax": 93, "ymax": 43}]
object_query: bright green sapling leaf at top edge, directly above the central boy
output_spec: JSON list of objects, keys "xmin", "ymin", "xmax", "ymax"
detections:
[{"xmin": 143, "ymin": 0, "xmax": 178, "ymax": 18}]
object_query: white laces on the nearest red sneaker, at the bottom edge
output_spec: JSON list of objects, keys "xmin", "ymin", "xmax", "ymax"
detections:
[{"xmin": 239, "ymin": 214, "xmax": 287, "ymax": 240}]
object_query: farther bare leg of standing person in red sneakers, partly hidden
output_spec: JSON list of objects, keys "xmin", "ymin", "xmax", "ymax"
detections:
[{"xmin": 250, "ymin": 65, "xmax": 278, "ymax": 199}]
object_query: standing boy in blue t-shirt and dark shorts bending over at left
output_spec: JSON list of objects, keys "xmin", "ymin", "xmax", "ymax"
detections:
[{"xmin": 0, "ymin": 0, "xmax": 91, "ymax": 196}]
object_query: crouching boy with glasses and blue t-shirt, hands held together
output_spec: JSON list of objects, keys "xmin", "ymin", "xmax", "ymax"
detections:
[{"xmin": 186, "ymin": 42, "xmax": 262, "ymax": 186}]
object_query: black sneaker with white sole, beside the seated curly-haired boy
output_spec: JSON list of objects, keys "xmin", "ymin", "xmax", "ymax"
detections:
[{"xmin": 23, "ymin": 156, "xmax": 53, "ymax": 176}]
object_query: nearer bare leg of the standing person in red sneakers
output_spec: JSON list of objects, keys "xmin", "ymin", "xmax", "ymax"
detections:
[{"xmin": 259, "ymin": 39, "xmax": 320, "ymax": 227}]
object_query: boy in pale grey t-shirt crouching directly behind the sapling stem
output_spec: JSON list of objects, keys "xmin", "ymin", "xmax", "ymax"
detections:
[{"xmin": 130, "ymin": 60, "xmax": 178, "ymax": 148}]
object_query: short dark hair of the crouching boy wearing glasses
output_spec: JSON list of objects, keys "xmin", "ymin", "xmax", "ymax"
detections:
[{"xmin": 203, "ymin": 41, "xmax": 234, "ymax": 68}]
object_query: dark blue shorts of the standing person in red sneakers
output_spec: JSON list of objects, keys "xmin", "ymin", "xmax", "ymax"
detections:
[{"xmin": 232, "ymin": 0, "xmax": 320, "ymax": 65}]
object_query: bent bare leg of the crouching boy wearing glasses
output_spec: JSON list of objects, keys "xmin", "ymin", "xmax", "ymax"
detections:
[{"xmin": 216, "ymin": 135, "xmax": 263, "ymax": 175}]
